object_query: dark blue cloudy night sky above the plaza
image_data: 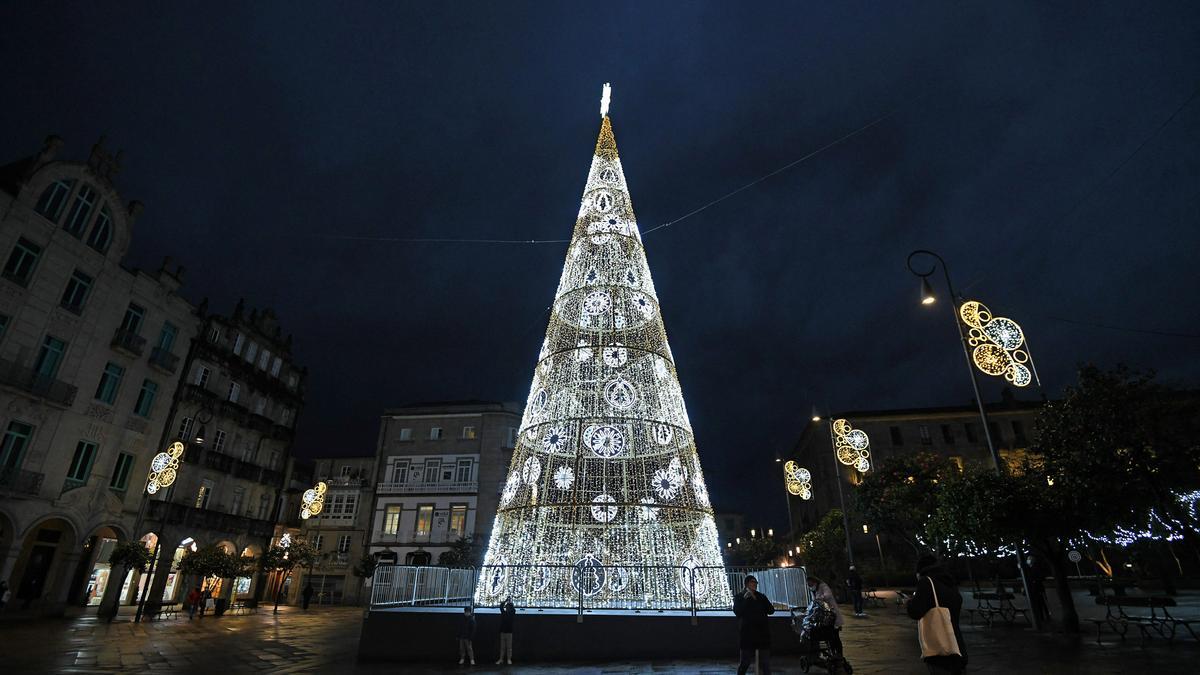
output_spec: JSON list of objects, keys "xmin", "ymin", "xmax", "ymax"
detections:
[{"xmin": 0, "ymin": 1, "xmax": 1200, "ymax": 525}]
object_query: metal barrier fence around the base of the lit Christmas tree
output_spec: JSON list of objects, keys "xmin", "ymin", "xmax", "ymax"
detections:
[{"xmin": 371, "ymin": 565, "xmax": 809, "ymax": 615}]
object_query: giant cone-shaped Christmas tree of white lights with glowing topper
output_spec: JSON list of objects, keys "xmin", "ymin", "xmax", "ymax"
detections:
[{"xmin": 475, "ymin": 85, "xmax": 732, "ymax": 608}]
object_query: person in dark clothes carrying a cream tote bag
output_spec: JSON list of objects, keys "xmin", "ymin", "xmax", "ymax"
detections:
[{"xmin": 907, "ymin": 555, "xmax": 967, "ymax": 675}]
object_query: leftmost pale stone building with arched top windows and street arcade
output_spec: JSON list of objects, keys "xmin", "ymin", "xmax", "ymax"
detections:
[{"xmin": 0, "ymin": 136, "xmax": 200, "ymax": 611}]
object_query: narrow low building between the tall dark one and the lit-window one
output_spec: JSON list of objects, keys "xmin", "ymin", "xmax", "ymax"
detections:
[{"xmin": 288, "ymin": 455, "xmax": 376, "ymax": 604}]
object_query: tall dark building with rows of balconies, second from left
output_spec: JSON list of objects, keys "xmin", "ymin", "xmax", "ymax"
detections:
[{"xmin": 139, "ymin": 301, "xmax": 307, "ymax": 610}]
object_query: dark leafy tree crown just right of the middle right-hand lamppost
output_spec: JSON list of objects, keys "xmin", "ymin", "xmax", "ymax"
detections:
[{"xmin": 853, "ymin": 453, "xmax": 959, "ymax": 551}]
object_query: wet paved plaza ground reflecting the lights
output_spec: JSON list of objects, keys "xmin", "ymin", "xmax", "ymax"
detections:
[{"xmin": 0, "ymin": 586, "xmax": 1200, "ymax": 675}]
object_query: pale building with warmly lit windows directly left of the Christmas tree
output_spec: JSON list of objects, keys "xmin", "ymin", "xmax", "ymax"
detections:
[{"xmin": 368, "ymin": 401, "xmax": 521, "ymax": 565}]
